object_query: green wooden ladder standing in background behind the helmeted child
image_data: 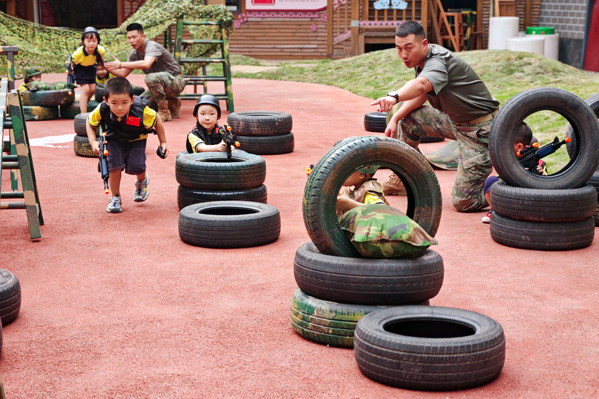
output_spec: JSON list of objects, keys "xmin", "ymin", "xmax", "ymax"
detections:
[{"xmin": 171, "ymin": 19, "xmax": 235, "ymax": 112}]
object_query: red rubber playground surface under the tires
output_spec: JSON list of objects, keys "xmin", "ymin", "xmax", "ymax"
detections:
[{"xmin": 0, "ymin": 74, "xmax": 599, "ymax": 399}]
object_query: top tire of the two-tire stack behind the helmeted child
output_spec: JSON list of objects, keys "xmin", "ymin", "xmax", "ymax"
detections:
[{"xmin": 227, "ymin": 111, "xmax": 293, "ymax": 136}]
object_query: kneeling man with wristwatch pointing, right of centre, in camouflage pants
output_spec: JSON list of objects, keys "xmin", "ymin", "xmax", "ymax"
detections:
[{"xmin": 372, "ymin": 21, "xmax": 499, "ymax": 212}]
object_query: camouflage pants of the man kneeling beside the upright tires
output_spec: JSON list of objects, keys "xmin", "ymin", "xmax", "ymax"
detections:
[{"xmin": 397, "ymin": 105, "xmax": 493, "ymax": 212}]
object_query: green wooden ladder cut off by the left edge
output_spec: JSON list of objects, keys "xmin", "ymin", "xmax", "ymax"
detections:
[{"xmin": 0, "ymin": 77, "xmax": 44, "ymax": 240}]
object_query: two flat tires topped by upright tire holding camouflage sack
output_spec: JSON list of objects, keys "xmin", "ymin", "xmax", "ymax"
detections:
[{"xmin": 291, "ymin": 136, "xmax": 444, "ymax": 348}]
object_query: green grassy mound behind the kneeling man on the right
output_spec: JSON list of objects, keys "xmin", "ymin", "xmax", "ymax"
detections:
[{"xmin": 223, "ymin": 49, "xmax": 599, "ymax": 171}]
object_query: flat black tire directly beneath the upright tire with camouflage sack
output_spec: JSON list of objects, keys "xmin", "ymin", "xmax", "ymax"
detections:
[{"xmin": 293, "ymin": 242, "xmax": 444, "ymax": 305}]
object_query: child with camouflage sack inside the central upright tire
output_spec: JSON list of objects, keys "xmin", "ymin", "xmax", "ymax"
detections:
[{"xmin": 336, "ymin": 165, "xmax": 437, "ymax": 258}]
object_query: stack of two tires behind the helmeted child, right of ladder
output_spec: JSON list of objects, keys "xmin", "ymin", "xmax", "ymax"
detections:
[{"xmin": 227, "ymin": 111, "xmax": 295, "ymax": 155}]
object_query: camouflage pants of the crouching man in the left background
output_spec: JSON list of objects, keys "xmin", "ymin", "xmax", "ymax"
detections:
[{"xmin": 141, "ymin": 72, "xmax": 185, "ymax": 119}]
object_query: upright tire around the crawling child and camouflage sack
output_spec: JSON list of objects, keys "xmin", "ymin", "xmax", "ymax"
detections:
[{"xmin": 303, "ymin": 136, "xmax": 441, "ymax": 257}]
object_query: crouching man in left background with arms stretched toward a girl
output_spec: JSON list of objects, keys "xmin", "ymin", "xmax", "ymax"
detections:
[{"xmin": 105, "ymin": 23, "xmax": 185, "ymax": 122}]
